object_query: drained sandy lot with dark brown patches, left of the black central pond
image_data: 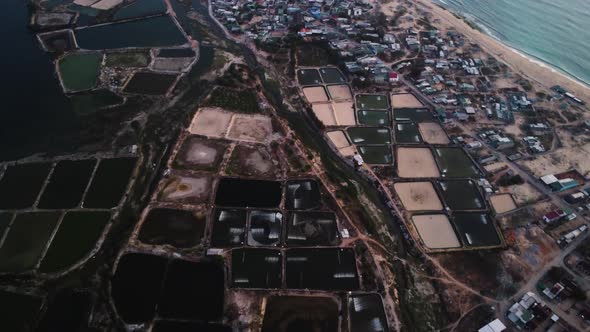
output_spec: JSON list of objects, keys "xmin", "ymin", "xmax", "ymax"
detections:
[{"xmin": 160, "ymin": 175, "xmax": 213, "ymax": 203}]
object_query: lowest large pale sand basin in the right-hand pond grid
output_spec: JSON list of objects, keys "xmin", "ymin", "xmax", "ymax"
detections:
[{"xmin": 412, "ymin": 214, "xmax": 461, "ymax": 249}]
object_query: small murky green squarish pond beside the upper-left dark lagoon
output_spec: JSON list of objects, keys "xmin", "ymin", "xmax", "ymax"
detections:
[{"xmin": 57, "ymin": 53, "xmax": 102, "ymax": 91}]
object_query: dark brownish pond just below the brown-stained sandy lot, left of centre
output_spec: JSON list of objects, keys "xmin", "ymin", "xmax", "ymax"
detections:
[{"xmin": 138, "ymin": 206, "xmax": 207, "ymax": 248}]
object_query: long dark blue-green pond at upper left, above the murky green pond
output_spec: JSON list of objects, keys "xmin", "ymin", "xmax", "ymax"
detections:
[{"xmin": 75, "ymin": 15, "xmax": 187, "ymax": 50}]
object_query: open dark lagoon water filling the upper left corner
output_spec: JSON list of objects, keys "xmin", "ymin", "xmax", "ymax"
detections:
[{"xmin": 0, "ymin": 0, "xmax": 78, "ymax": 160}]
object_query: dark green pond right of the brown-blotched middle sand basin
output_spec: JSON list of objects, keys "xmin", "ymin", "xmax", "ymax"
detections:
[{"xmin": 438, "ymin": 180, "xmax": 485, "ymax": 210}]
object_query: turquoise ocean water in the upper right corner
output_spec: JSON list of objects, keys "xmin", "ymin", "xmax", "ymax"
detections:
[{"xmin": 434, "ymin": 0, "xmax": 590, "ymax": 85}]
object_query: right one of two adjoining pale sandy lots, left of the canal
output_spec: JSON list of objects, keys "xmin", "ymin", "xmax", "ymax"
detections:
[{"xmin": 227, "ymin": 114, "xmax": 272, "ymax": 143}]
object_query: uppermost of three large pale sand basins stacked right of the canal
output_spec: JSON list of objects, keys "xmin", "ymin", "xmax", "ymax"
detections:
[{"xmin": 397, "ymin": 147, "xmax": 440, "ymax": 178}]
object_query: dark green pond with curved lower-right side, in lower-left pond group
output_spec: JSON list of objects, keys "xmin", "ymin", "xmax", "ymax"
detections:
[{"xmin": 39, "ymin": 211, "xmax": 111, "ymax": 273}]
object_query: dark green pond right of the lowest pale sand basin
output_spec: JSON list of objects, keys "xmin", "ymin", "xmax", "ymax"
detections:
[{"xmin": 453, "ymin": 213, "xmax": 502, "ymax": 247}]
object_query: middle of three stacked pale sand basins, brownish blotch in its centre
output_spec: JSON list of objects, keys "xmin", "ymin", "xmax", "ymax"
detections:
[{"xmin": 393, "ymin": 182, "xmax": 443, "ymax": 211}]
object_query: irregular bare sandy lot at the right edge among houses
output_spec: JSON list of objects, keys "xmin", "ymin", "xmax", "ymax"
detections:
[{"xmin": 519, "ymin": 143, "xmax": 590, "ymax": 178}]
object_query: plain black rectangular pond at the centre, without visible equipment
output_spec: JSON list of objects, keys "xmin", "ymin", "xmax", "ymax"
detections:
[{"xmin": 215, "ymin": 178, "xmax": 282, "ymax": 207}]
